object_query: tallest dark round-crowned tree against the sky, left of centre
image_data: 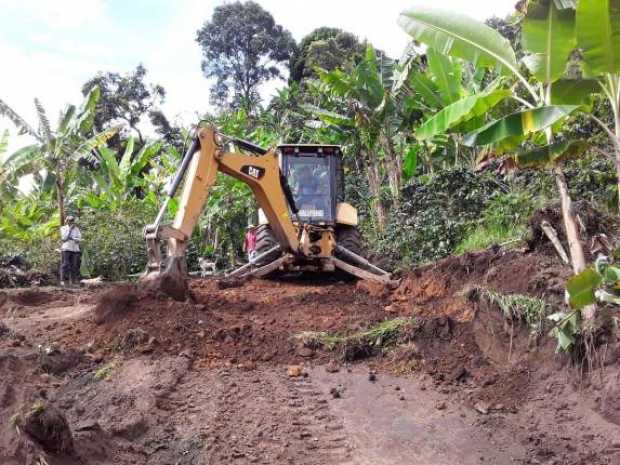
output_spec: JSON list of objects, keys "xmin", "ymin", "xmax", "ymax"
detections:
[{"xmin": 196, "ymin": 1, "xmax": 295, "ymax": 112}]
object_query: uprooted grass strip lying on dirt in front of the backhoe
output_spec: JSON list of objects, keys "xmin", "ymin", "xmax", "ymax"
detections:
[{"xmin": 293, "ymin": 318, "xmax": 416, "ymax": 359}]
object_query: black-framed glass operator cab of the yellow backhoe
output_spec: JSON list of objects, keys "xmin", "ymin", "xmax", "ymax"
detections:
[{"xmin": 278, "ymin": 144, "xmax": 344, "ymax": 225}]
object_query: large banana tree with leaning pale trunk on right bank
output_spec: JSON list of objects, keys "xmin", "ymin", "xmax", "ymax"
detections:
[{"xmin": 399, "ymin": 0, "xmax": 593, "ymax": 317}]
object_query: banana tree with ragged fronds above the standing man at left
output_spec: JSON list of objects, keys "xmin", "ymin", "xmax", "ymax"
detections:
[{"xmin": 0, "ymin": 87, "xmax": 116, "ymax": 223}]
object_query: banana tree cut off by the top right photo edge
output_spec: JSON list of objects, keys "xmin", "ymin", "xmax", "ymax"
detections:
[{"xmin": 575, "ymin": 0, "xmax": 620, "ymax": 209}]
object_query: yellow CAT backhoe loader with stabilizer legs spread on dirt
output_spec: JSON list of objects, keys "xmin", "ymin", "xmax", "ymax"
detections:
[{"xmin": 142, "ymin": 127, "xmax": 390, "ymax": 300}]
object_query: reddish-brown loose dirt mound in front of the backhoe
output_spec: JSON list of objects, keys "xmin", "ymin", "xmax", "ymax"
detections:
[{"xmin": 51, "ymin": 279, "xmax": 390, "ymax": 364}]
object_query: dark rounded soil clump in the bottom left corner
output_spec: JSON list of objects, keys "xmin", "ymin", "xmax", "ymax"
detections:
[{"xmin": 23, "ymin": 402, "xmax": 73, "ymax": 454}]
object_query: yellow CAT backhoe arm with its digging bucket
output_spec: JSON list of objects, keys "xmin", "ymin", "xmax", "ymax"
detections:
[{"xmin": 143, "ymin": 127, "xmax": 299, "ymax": 300}]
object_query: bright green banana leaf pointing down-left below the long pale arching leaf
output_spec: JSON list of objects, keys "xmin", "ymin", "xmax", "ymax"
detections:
[{"xmin": 415, "ymin": 90, "xmax": 511, "ymax": 140}]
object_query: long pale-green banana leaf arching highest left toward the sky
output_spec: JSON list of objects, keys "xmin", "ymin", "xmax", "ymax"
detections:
[{"xmin": 398, "ymin": 1, "xmax": 518, "ymax": 74}]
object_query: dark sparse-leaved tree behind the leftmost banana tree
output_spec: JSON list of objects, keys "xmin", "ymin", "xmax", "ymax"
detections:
[{"xmin": 82, "ymin": 65, "xmax": 175, "ymax": 146}]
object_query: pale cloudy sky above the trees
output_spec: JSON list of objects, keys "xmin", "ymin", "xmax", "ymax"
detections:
[{"xmin": 0, "ymin": 0, "xmax": 516, "ymax": 148}]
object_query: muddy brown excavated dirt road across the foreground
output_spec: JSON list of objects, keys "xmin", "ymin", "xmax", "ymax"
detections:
[{"xmin": 0, "ymin": 251, "xmax": 620, "ymax": 465}]
